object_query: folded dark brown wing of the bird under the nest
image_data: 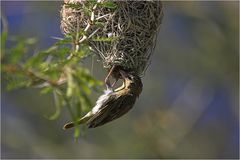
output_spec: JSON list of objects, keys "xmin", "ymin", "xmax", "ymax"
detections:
[{"xmin": 87, "ymin": 95, "xmax": 136, "ymax": 128}]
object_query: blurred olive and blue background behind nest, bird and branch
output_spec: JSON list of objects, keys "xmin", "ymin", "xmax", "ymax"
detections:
[{"xmin": 1, "ymin": 1, "xmax": 239, "ymax": 159}]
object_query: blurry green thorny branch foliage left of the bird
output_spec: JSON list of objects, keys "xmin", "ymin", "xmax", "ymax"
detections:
[{"xmin": 1, "ymin": 30, "xmax": 102, "ymax": 137}]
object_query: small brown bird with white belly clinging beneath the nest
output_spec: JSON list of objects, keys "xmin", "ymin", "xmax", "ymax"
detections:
[{"xmin": 63, "ymin": 66, "xmax": 143, "ymax": 129}]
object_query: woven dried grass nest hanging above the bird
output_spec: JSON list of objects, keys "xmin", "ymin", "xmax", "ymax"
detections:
[{"xmin": 61, "ymin": 0, "xmax": 163, "ymax": 75}]
